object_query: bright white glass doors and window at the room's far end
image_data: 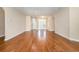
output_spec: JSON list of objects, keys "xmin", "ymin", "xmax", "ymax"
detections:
[{"xmin": 32, "ymin": 18, "xmax": 46, "ymax": 30}]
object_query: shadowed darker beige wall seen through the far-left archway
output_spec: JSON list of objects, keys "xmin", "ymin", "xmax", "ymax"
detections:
[{"xmin": 0, "ymin": 7, "xmax": 5, "ymax": 37}]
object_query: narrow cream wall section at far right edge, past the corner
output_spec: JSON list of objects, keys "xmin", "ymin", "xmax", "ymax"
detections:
[{"xmin": 70, "ymin": 7, "xmax": 79, "ymax": 41}]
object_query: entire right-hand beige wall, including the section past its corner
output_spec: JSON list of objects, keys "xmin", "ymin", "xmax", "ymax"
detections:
[{"xmin": 51, "ymin": 7, "xmax": 79, "ymax": 41}]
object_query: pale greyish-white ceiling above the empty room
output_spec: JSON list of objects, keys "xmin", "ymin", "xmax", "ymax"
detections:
[{"xmin": 15, "ymin": 7, "xmax": 61, "ymax": 16}]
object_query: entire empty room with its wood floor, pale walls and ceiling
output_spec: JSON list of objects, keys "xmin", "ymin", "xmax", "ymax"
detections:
[{"xmin": 0, "ymin": 7, "xmax": 79, "ymax": 52}]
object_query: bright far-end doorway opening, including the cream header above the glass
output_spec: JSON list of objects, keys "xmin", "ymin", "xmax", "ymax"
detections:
[{"xmin": 32, "ymin": 16, "xmax": 47, "ymax": 30}]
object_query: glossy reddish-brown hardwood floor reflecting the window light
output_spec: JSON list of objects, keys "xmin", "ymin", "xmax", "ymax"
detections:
[{"xmin": 0, "ymin": 31, "xmax": 79, "ymax": 52}]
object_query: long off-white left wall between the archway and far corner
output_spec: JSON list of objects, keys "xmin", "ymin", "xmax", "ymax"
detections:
[{"xmin": 4, "ymin": 7, "xmax": 26, "ymax": 40}]
